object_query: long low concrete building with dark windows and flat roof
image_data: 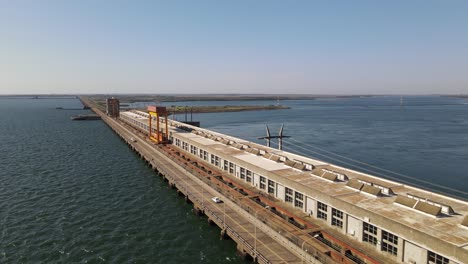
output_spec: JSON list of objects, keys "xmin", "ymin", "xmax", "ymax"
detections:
[{"xmin": 120, "ymin": 111, "xmax": 468, "ymax": 264}]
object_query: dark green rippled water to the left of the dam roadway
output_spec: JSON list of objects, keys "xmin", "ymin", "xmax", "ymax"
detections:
[{"xmin": 0, "ymin": 99, "xmax": 242, "ymax": 263}]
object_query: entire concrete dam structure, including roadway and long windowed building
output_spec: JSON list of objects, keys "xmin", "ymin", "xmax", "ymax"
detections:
[{"xmin": 80, "ymin": 95, "xmax": 468, "ymax": 264}]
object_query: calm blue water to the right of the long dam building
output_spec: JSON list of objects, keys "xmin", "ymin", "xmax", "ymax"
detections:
[{"xmin": 188, "ymin": 96, "xmax": 468, "ymax": 198}]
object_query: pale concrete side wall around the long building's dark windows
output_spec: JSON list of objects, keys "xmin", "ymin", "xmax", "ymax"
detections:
[{"xmin": 166, "ymin": 135, "xmax": 468, "ymax": 263}]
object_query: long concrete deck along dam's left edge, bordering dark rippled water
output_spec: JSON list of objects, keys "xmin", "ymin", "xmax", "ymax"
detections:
[{"xmin": 85, "ymin": 97, "xmax": 314, "ymax": 263}]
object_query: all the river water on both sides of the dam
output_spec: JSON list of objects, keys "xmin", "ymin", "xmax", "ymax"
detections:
[{"xmin": 0, "ymin": 96, "xmax": 468, "ymax": 263}]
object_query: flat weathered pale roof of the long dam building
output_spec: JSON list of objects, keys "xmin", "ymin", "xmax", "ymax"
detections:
[{"xmin": 119, "ymin": 112, "xmax": 468, "ymax": 252}]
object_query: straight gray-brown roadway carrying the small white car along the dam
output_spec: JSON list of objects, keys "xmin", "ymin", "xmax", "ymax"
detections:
[{"xmin": 98, "ymin": 116, "xmax": 308, "ymax": 263}]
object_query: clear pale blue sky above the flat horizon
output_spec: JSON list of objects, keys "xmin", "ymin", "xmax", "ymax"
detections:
[{"xmin": 0, "ymin": 0, "xmax": 468, "ymax": 94}]
